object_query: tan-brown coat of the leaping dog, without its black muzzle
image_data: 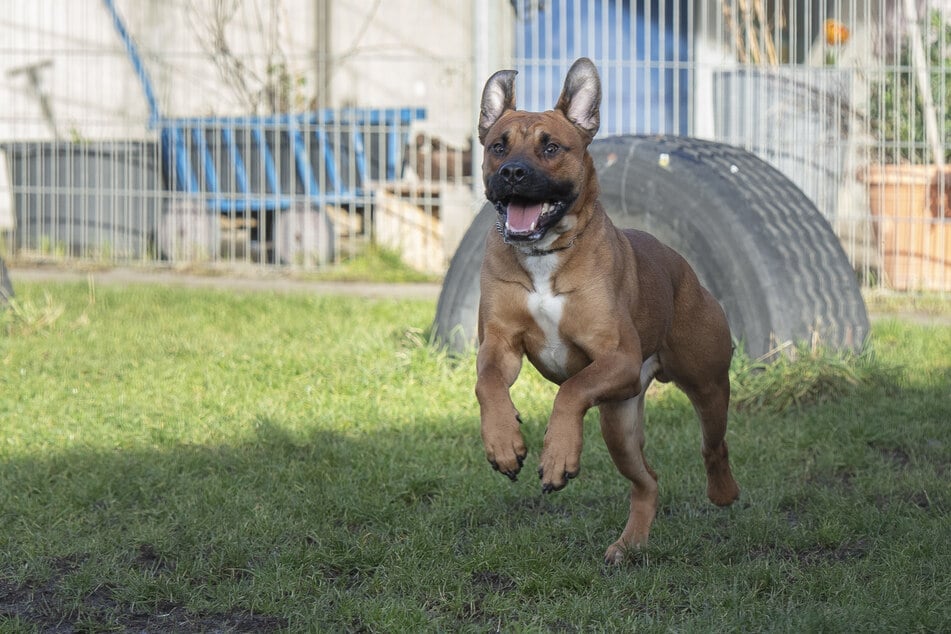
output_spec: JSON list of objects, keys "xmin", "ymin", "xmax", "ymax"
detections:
[{"xmin": 476, "ymin": 59, "xmax": 739, "ymax": 563}]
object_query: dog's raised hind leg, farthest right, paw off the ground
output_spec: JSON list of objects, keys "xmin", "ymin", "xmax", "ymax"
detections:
[{"xmin": 684, "ymin": 373, "xmax": 740, "ymax": 506}]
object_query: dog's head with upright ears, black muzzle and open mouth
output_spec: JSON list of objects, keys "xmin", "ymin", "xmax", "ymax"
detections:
[{"xmin": 479, "ymin": 58, "xmax": 601, "ymax": 246}]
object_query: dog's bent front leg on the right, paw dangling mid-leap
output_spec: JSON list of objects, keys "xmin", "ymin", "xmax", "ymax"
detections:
[{"xmin": 538, "ymin": 349, "xmax": 641, "ymax": 493}]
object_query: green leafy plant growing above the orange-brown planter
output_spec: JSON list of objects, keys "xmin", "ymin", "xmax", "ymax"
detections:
[{"xmin": 869, "ymin": 11, "xmax": 951, "ymax": 164}]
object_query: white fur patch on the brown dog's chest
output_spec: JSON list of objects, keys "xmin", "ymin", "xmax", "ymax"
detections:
[{"xmin": 524, "ymin": 254, "xmax": 568, "ymax": 374}]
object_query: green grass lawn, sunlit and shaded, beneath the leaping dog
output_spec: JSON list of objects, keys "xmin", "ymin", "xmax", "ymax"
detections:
[{"xmin": 0, "ymin": 284, "xmax": 951, "ymax": 632}]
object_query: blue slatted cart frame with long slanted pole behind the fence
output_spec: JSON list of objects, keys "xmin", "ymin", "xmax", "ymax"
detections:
[{"xmin": 103, "ymin": 0, "xmax": 426, "ymax": 213}]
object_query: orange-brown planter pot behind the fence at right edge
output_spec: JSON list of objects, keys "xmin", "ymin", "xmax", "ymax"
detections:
[{"xmin": 862, "ymin": 165, "xmax": 951, "ymax": 291}]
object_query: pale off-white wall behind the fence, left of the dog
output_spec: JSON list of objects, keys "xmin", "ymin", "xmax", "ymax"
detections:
[{"xmin": 0, "ymin": 0, "xmax": 511, "ymax": 143}]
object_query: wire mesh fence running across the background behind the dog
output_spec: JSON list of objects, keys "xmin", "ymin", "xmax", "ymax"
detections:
[{"xmin": 0, "ymin": 0, "xmax": 951, "ymax": 291}]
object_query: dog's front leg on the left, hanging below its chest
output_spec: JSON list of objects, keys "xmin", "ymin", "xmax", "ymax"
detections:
[{"xmin": 476, "ymin": 335, "xmax": 528, "ymax": 480}]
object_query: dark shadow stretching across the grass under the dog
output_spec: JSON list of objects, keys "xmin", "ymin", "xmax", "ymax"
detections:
[{"xmin": 0, "ymin": 376, "xmax": 951, "ymax": 632}]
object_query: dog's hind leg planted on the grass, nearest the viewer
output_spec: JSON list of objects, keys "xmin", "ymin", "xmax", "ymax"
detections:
[{"xmin": 599, "ymin": 366, "xmax": 657, "ymax": 564}]
